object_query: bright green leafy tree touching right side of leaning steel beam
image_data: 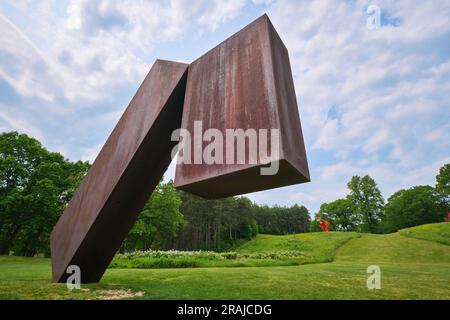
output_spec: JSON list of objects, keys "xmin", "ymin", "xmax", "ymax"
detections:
[{"xmin": 123, "ymin": 181, "xmax": 186, "ymax": 250}]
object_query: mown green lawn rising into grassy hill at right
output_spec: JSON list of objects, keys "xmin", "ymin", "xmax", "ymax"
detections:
[{"xmin": 0, "ymin": 223, "xmax": 450, "ymax": 299}]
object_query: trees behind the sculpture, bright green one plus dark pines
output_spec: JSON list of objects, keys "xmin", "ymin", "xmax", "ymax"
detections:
[{"xmin": 121, "ymin": 181, "xmax": 310, "ymax": 252}]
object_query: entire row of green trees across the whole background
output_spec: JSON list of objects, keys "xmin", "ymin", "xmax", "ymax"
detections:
[{"xmin": 0, "ymin": 132, "xmax": 450, "ymax": 256}]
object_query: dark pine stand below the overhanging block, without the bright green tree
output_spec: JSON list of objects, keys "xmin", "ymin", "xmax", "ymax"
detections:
[{"xmin": 163, "ymin": 192, "xmax": 310, "ymax": 251}]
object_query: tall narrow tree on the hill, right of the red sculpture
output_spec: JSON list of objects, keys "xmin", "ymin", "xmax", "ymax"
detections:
[{"xmin": 347, "ymin": 175, "xmax": 384, "ymax": 232}]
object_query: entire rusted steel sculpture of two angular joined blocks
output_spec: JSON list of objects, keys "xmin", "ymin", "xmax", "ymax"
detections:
[{"xmin": 51, "ymin": 15, "xmax": 309, "ymax": 283}]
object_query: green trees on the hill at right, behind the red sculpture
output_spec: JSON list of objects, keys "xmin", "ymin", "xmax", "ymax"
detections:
[{"xmin": 310, "ymin": 164, "xmax": 450, "ymax": 233}]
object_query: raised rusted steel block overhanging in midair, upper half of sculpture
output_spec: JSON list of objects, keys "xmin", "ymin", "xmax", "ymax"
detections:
[{"xmin": 175, "ymin": 15, "xmax": 310, "ymax": 199}]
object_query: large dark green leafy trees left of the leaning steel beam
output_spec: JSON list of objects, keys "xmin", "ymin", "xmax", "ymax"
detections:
[{"xmin": 0, "ymin": 132, "xmax": 89, "ymax": 256}]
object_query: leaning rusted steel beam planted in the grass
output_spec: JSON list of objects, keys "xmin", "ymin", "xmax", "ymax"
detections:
[{"xmin": 51, "ymin": 60, "xmax": 188, "ymax": 283}]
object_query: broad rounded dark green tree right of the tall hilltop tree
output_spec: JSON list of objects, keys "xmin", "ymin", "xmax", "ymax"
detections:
[{"xmin": 385, "ymin": 186, "xmax": 445, "ymax": 232}]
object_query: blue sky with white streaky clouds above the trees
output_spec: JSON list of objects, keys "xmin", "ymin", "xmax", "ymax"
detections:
[{"xmin": 0, "ymin": 0, "xmax": 450, "ymax": 212}]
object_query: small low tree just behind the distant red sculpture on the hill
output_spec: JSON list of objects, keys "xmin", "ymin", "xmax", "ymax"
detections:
[{"xmin": 319, "ymin": 198, "xmax": 357, "ymax": 231}]
